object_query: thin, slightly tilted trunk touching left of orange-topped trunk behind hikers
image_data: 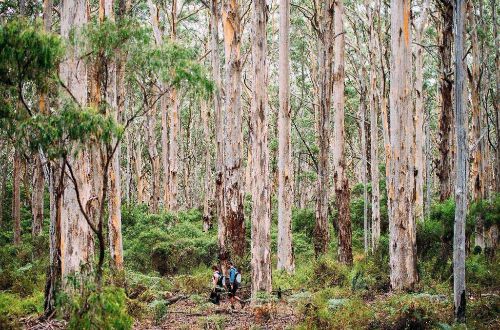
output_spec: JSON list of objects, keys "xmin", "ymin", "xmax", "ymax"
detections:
[{"xmin": 210, "ymin": 0, "xmax": 229, "ymax": 267}]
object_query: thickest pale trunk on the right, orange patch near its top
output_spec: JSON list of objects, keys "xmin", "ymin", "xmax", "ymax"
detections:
[{"xmin": 388, "ymin": 0, "xmax": 417, "ymax": 290}]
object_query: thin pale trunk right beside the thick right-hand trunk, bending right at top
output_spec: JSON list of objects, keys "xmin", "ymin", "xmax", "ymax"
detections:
[{"xmin": 413, "ymin": 0, "xmax": 430, "ymax": 221}]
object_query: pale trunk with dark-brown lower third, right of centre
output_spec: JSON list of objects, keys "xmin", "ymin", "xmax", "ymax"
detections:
[{"xmin": 333, "ymin": 0, "xmax": 354, "ymax": 264}]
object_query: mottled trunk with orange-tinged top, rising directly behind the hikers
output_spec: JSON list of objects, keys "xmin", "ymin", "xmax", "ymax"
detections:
[{"xmin": 222, "ymin": 0, "xmax": 245, "ymax": 258}]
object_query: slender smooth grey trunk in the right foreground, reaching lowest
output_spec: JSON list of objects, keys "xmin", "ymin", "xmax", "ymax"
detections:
[{"xmin": 453, "ymin": 0, "xmax": 468, "ymax": 323}]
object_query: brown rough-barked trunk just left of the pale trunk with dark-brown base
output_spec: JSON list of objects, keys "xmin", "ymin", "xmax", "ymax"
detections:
[{"xmin": 314, "ymin": 0, "xmax": 333, "ymax": 256}]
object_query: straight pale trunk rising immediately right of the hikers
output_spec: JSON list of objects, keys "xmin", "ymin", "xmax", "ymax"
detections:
[{"xmin": 249, "ymin": 0, "xmax": 272, "ymax": 299}]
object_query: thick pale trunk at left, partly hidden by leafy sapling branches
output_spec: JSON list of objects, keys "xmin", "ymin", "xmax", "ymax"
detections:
[{"xmin": 60, "ymin": 0, "xmax": 94, "ymax": 281}]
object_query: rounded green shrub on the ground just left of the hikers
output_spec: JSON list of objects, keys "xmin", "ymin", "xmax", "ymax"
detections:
[{"xmin": 123, "ymin": 206, "xmax": 217, "ymax": 275}]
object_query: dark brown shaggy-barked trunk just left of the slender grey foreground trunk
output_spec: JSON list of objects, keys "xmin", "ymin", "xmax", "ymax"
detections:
[{"xmin": 437, "ymin": 0, "xmax": 454, "ymax": 201}]
